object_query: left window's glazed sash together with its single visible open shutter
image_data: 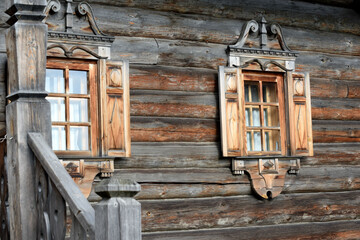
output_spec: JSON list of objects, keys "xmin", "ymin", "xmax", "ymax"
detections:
[{"xmin": 45, "ymin": 59, "xmax": 130, "ymax": 156}]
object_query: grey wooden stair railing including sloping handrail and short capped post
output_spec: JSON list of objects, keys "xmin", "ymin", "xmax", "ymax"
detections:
[{"xmin": 28, "ymin": 133, "xmax": 141, "ymax": 240}]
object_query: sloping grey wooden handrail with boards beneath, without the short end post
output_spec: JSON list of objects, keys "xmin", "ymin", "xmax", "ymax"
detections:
[{"xmin": 28, "ymin": 133, "xmax": 95, "ymax": 239}]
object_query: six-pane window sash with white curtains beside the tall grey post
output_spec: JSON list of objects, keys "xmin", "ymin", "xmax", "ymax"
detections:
[{"xmin": 45, "ymin": 60, "xmax": 98, "ymax": 155}]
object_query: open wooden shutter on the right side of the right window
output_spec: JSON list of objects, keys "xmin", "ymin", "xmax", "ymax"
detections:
[{"xmin": 288, "ymin": 72, "xmax": 313, "ymax": 156}]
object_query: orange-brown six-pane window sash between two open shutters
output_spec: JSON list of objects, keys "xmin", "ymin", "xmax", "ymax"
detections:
[{"xmin": 243, "ymin": 73, "xmax": 285, "ymax": 155}]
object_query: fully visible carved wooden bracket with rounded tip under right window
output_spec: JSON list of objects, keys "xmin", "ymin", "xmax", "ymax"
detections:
[{"xmin": 232, "ymin": 158, "xmax": 300, "ymax": 199}]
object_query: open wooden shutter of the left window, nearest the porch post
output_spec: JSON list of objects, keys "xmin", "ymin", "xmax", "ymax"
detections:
[{"xmin": 100, "ymin": 60, "xmax": 130, "ymax": 157}]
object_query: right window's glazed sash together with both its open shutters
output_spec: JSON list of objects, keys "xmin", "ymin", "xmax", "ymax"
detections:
[{"xmin": 219, "ymin": 67, "xmax": 312, "ymax": 156}]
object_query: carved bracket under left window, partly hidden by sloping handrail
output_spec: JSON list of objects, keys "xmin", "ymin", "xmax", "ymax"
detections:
[{"xmin": 61, "ymin": 159, "xmax": 114, "ymax": 197}]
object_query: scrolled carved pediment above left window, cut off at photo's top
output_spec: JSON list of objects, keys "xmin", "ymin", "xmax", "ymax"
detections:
[{"xmin": 43, "ymin": 0, "xmax": 115, "ymax": 59}]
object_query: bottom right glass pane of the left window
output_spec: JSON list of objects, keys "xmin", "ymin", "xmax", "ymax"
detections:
[{"xmin": 70, "ymin": 126, "xmax": 89, "ymax": 151}]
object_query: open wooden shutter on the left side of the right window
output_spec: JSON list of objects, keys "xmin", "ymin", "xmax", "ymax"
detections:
[{"xmin": 219, "ymin": 66, "xmax": 246, "ymax": 157}]
